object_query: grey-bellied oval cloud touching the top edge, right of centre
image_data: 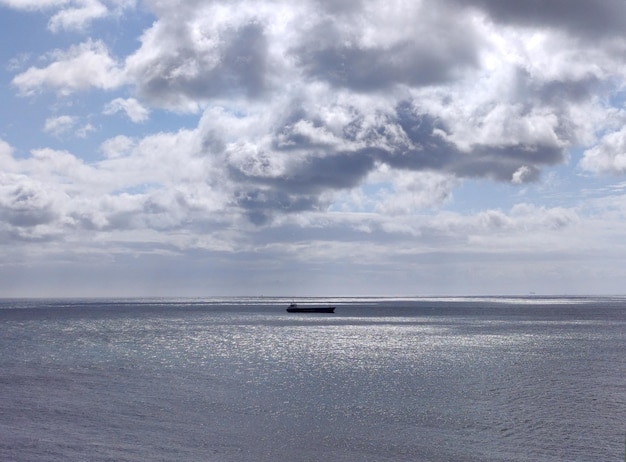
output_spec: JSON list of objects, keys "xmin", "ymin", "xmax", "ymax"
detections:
[{"xmin": 292, "ymin": 2, "xmax": 480, "ymax": 92}]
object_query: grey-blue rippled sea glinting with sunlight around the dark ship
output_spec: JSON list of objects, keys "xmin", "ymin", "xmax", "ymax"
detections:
[{"xmin": 0, "ymin": 296, "xmax": 626, "ymax": 462}]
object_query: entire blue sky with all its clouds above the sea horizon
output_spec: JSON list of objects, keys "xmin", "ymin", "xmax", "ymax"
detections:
[{"xmin": 0, "ymin": 0, "xmax": 626, "ymax": 297}]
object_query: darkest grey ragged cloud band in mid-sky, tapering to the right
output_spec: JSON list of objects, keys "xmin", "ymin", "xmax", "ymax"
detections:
[{"xmin": 229, "ymin": 101, "xmax": 564, "ymax": 224}]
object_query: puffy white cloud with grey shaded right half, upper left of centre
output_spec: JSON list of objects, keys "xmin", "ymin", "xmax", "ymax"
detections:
[{"xmin": 126, "ymin": 6, "xmax": 268, "ymax": 111}]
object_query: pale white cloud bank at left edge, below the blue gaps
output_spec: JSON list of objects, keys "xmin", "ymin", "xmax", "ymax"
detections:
[{"xmin": 0, "ymin": 125, "xmax": 236, "ymax": 242}]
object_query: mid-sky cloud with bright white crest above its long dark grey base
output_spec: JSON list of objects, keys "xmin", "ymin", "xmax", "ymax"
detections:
[{"xmin": 219, "ymin": 98, "xmax": 563, "ymax": 221}]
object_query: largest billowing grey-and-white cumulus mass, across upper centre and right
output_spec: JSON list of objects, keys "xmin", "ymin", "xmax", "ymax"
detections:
[{"xmin": 114, "ymin": 1, "xmax": 619, "ymax": 223}]
